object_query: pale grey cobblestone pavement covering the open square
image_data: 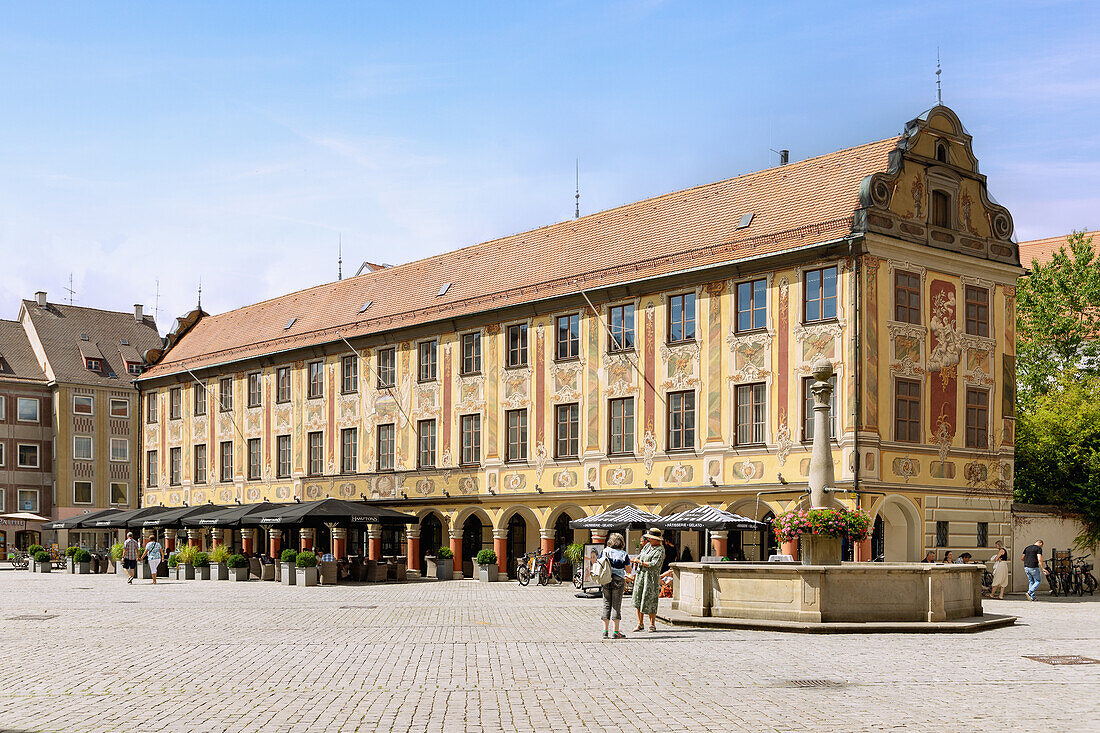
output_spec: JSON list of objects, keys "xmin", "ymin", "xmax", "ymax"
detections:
[{"xmin": 0, "ymin": 570, "xmax": 1100, "ymax": 732}]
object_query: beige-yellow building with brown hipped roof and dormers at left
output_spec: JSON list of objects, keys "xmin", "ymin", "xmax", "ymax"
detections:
[{"xmin": 19, "ymin": 292, "xmax": 162, "ymax": 541}]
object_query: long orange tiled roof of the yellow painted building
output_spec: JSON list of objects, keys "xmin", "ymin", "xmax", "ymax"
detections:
[{"xmin": 142, "ymin": 138, "xmax": 899, "ymax": 379}]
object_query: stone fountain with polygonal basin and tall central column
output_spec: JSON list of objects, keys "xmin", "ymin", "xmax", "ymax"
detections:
[{"xmin": 662, "ymin": 361, "xmax": 1014, "ymax": 632}]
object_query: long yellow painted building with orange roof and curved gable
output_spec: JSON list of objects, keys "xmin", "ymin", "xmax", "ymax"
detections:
[{"xmin": 139, "ymin": 107, "xmax": 1022, "ymax": 575}]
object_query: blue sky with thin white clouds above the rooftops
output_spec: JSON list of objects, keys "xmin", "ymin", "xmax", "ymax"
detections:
[{"xmin": 0, "ymin": 0, "xmax": 1100, "ymax": 332}]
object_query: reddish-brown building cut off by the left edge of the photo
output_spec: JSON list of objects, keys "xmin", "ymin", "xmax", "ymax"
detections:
[{"xmin": 0, "ymin": 320, "xmax": 54, "ymax": 557}]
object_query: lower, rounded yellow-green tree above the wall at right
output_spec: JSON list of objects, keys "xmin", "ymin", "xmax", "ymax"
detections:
[{"xmin": 1015, "ymin": 373, "xmax": 1100, "ymax": 547}]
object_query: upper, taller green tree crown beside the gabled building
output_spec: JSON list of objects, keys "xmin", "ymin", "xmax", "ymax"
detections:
[{"xmin": 1016, "ymin": 231, "xmax": 1100, "ymax": 409}]
